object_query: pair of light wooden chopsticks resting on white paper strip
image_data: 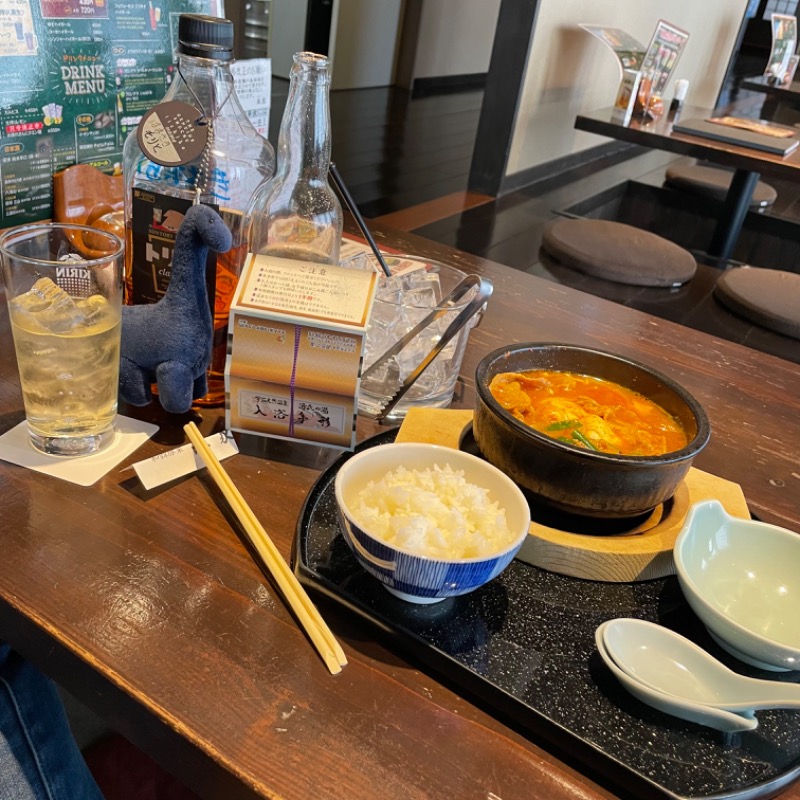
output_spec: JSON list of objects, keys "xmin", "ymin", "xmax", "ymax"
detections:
[{"xmin": 184, "ymin": 422, "xmax": 347, "ymax": 675}]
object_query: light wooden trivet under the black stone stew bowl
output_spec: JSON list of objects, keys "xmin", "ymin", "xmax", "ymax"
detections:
[{"xmin": 396, "ymin": 408, "xmax": 750, "ymax": 583}]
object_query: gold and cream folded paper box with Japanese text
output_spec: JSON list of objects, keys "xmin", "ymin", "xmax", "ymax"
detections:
[{"xmin": 225, "ymin": 255, "xmax": 377, "ymax": 449}]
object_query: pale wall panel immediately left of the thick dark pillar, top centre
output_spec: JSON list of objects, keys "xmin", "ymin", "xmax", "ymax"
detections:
[{"xmin": 414, "ymin": 0, "xmax": 500, "ymax": 78}]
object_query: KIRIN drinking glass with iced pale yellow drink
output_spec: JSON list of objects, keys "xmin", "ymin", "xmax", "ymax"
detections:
[{"xmin": 0, "ymin": 223, "xmax": 124, "ymax": 456}]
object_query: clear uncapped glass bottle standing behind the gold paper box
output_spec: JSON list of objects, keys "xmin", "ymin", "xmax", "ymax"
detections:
[{"xmin": 248, "ymin": 53, "xmax": 342, "ymax": 264}]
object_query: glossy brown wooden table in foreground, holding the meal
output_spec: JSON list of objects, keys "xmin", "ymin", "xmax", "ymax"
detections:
[{"xmin": 0, "ymin": 223, "xmax": 800, "ymax": 800}]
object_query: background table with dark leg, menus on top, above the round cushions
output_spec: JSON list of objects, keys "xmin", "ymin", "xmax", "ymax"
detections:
[{"xmin": 575, "ymin": 106, "xmax": 800, "ymax": 261}]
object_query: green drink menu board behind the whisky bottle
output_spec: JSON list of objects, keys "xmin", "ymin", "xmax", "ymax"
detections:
[{"xmin": 0, "ymin": 0, "xmax": 222, "ymax": 228}]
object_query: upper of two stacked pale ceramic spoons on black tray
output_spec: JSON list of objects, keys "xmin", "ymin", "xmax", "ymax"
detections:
[{"xmin": 603, "ymin": 619, "xmax": 800, "ymax": 713}]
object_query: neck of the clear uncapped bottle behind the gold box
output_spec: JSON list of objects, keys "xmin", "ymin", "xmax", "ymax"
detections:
[{"xmin": 278, "ymin": 54, "xmax": 331, "ymax": 180}]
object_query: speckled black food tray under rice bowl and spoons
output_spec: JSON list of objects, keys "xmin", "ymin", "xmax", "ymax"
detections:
[{"xmin": 294, "ymin": 430, "xmax": 800, "ymax": 800}]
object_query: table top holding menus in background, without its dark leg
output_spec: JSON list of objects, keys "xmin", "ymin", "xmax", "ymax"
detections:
[{"xmin": 575, "ymin": 106, "xmax": 800, "ymax": 179}]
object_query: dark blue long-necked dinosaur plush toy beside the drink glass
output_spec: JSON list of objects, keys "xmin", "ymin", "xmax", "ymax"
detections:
[{"xmin": 119, "ymin": 205, "xmax": 232, "ymax": 414}]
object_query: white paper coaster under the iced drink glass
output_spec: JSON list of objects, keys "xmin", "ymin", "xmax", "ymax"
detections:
[{"xmin": 0, "ymin": 417, "xmax": 158, "ymax": 486}]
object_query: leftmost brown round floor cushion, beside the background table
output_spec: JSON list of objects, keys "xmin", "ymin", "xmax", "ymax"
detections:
[{"xmin": 542, "ymin": 218, "xmax": 697, "ymax": 286}]
